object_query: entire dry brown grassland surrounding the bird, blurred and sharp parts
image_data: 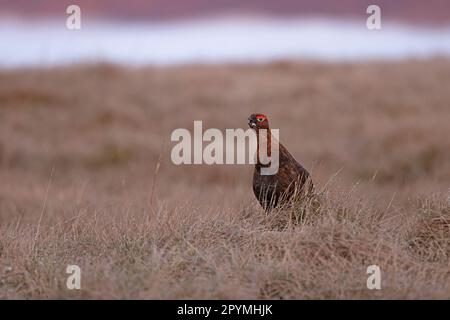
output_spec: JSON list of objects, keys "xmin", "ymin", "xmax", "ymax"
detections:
[{"xmin": 0, "ymin": 59, "xmax": 450, "ymax": 299}]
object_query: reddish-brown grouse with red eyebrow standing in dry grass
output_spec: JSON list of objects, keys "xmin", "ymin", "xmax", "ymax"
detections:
[{"xmin": 248, "ymin": 114, "xmax": 313, "ymax": 210}]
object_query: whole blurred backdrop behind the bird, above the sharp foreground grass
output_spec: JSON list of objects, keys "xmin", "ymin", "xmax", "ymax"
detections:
[{"xmin": 0, "ymin": 0, "xmax": 450, "ymax": 206}]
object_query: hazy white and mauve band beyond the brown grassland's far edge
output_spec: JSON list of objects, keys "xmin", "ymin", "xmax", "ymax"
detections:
[{"xmin": 0, "ymin": 0, "xmax": 450, "ymax": 67}]
